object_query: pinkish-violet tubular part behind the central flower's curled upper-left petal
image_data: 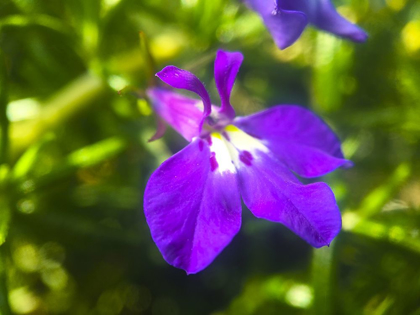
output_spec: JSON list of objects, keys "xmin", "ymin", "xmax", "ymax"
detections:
[{"xmin": 147, "ymin": 88, "xmax": 203, "ymax": 141}]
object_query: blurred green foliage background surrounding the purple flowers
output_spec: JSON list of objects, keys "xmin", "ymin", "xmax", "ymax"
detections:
[{"xmin": 0, "ymin": 0, "xmax": 420, "ymax": 315}]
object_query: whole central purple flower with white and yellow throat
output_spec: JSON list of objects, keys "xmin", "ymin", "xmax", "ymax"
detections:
[{"xmin": 144, "ymin": 51, "xmax": 351, "ymax": 274}]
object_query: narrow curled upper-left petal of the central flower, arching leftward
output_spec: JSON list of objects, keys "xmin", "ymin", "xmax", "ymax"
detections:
[{"xmin": 156, "ymin": 66, "xmax": 211, "ymax": 135}]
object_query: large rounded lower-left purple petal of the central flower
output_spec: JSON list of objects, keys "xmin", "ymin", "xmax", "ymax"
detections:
[{"xmin": 144, "ymin": 138, "xmax": 241, "ymax": 274}]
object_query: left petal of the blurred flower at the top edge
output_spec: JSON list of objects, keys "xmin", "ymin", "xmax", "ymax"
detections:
[{"xmin": 245, "ymin": 0, "xmax": 306, "ymax": 49}]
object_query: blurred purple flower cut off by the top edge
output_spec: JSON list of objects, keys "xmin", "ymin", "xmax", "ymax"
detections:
[{"xmin": 244, "ymin": 0, "xmax": 367, "ymax": 49}]
